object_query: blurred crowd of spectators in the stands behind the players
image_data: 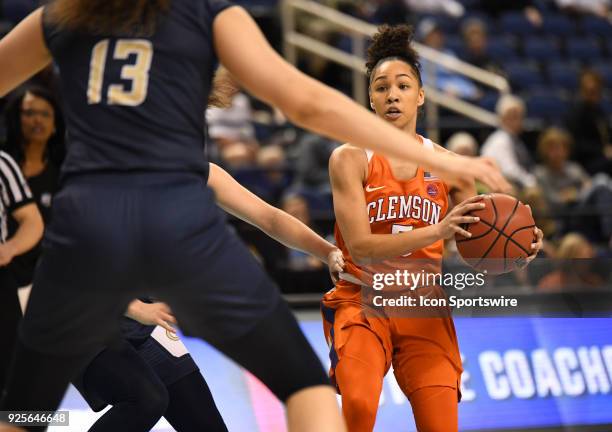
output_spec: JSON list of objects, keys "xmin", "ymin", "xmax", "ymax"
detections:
[{"xmin": 0, "ymin": 0, "xmax": 612, "ymax": 293}]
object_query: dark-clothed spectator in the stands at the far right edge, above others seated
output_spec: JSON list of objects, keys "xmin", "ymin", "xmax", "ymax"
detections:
[{"xmin": 567, "ymin": 70, "xmax": 612, "ymax": 174}]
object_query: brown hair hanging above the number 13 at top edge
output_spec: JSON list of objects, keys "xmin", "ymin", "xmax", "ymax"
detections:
[{"xmin": 47, "ymin": 0, "xmax": 171, "ymax": 36}]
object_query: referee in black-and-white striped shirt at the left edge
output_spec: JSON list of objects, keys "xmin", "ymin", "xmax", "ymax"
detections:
[{"xmin": 0, "ymin": 151, "xmax": 43, "ymax": 395}]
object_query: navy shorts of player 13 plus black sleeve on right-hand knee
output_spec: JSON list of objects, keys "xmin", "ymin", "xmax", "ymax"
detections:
[{"xmin": 20, "ymin": 173, "xmax": 327, "ymax": 398}]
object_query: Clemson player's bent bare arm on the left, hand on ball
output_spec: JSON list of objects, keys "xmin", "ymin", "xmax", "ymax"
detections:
[{"xmin": 329, "ymin": 145, "xmax": 482, "ymax": 264}]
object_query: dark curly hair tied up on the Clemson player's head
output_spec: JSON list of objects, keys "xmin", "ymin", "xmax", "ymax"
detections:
[{"xmin": 366, "ymin": 24, "xmax": 423, "ymax": 86}]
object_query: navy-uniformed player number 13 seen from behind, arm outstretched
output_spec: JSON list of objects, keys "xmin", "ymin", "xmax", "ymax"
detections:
[{"xmin": 0, "ymin": 0, "xmax": 509, "ymax": 431}]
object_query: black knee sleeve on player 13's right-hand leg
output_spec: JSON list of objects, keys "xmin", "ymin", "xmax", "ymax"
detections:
[{"xmin": 217, "ymin": 300, "xmax": 330, "ymax": 402}]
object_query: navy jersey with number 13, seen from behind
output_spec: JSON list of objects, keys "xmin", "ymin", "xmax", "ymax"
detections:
[{"xmin": 44, "ymin": 0, "xmax": 231, "ymax": 175}]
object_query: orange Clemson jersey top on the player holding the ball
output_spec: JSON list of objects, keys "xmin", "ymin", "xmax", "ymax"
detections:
[{"xmin": 334, "ymin": 136, "xmax": 448, "ymax": 287}]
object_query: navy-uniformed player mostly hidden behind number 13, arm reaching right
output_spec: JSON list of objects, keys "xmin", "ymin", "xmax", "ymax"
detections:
[{"xmin": 74, "ymin": 68, "xmax": 343, "ymax": 432}]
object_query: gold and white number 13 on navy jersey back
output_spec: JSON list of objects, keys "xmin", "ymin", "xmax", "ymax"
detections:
[{"xmin": 87, "ymin": 39, "xmax": 153, "ymax": 106}]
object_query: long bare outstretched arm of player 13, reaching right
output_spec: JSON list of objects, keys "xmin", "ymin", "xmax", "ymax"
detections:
[{"xmin": 213, "ymin": 7, "xmax": 510, "ymax": 190}]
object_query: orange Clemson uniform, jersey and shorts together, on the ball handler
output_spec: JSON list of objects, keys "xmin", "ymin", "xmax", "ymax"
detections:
[{"xmin": 321, "ymin": 137, "xmax": 462, "ymax": 398}]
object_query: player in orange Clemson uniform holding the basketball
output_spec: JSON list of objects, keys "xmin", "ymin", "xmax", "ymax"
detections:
[{"xmin": 322, "ymin": 25, "xmax": 541, "ymax": 432}]
